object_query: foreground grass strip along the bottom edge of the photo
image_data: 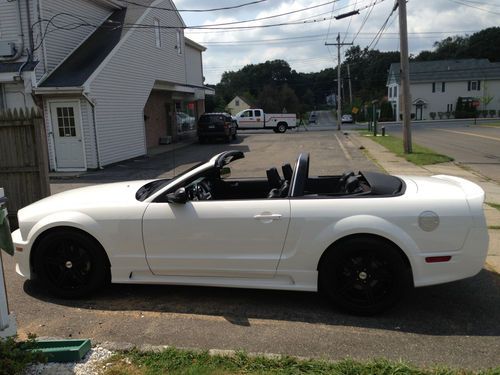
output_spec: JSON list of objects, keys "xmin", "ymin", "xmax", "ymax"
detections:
[{"xmin": 104, "ymin": 348, "xmax": 500, "ymax": 375}]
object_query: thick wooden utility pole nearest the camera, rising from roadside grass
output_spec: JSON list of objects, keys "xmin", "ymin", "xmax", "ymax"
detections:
[{"xmin": 394, "ymin": 0, "xmax": 413, "ymax": 154}]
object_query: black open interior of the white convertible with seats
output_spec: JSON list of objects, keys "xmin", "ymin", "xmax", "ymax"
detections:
[{"xmin": 154, "ymin": 153, "xmax": 404, "ymax": 201}]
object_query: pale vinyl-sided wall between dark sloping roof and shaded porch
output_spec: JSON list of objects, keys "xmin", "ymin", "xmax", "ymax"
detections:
[{"xmin": 90, "ymin": 0, "xmax": 186, "ymax": 165}]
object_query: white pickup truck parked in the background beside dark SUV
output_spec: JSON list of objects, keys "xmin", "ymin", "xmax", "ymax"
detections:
[{"xmin": 235, "ymin": 109, "xmax": 297, "ymax": 133}]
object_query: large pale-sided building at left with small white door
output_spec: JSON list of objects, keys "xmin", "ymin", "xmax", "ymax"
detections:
[{"xmin": 0, "ymin": 0, "xmax": 213, "ymax": 171}]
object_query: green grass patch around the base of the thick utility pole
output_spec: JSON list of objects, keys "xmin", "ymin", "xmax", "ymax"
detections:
[{"xmin": 361, "ymin": 130, "xmax": 453, "ymax": 165}]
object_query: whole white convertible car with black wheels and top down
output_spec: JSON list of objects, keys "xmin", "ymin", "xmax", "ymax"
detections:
[{"xmin": 13, "ymin": 151, "xmax": 488, "ymax": 314}]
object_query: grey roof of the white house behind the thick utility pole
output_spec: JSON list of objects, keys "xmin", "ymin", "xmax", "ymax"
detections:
[{"xmin": 387, "ymin": 59, "xmax": 500, "ymax": 84}]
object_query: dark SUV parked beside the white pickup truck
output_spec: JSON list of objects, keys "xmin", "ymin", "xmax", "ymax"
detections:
[{"xmin": 198, "ymin": 113, "xmax": 236, "ymax": 143}]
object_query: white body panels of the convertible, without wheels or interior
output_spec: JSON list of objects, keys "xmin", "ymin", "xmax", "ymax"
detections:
[{"xmin": 13, "ymin": 153, "xmax": 488, "ymax": 291}]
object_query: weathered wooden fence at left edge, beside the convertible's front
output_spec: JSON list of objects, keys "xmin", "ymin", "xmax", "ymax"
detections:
[{"xmin": 0, "ymin": 109, "xmax": 50, "ymax": 229}]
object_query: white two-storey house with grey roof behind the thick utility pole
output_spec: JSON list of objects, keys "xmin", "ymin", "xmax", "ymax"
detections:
[{"xmin": 387, "ymin": 59, "xmax": 500, "ymax": 120}]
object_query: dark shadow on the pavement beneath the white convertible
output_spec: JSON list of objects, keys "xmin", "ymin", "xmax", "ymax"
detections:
[{"xmin": 24, "ymin": 269, "xmax": 500, "ymax": 336}]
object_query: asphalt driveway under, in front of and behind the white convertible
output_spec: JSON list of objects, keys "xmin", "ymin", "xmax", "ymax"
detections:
[{"xmin": 4, "ymin": 129, "xmax": 500, "ymax": 368}]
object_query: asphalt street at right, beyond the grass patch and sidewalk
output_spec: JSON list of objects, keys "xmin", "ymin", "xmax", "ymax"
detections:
[{"xmin": 380, "ymin": 121, "xmax": 500, "ymax": 183}]
